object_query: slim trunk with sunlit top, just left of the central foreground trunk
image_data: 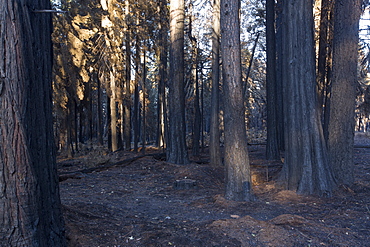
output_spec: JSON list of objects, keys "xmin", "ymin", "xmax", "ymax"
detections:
[{"xmin": 209, "ymin": 0, "xmax": 222, "ymax": 165}]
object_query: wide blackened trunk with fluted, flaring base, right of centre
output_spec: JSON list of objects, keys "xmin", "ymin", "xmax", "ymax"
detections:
[{"xmin": 282, "ymin": 0, "xmax": 333, "ymax": 196}]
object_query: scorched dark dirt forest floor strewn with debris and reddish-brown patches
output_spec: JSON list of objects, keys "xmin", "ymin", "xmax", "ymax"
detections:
[{"xmin": 58, "ymin": 135, "xmax": 370, "ymax": 247}]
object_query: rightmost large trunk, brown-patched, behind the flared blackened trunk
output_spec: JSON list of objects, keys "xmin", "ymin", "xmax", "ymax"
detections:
[{"xmin": 328, "ymin": 0, "xmax": 361, "ymax": 185}]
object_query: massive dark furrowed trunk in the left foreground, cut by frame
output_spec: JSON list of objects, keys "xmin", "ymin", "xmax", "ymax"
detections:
[{"xmin": 0, "ymin": 0, "xmax": 66, "ymax": 246}]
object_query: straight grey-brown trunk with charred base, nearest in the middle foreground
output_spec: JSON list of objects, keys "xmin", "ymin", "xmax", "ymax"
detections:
[{"xmin": 221, "ymin": 0, "xmax": 252, "ymax": 201}]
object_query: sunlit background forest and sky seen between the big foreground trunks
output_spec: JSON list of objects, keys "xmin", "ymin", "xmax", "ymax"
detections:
[{"xmin": 49, "ymin": 0, "xmax": 370, "ymax": 185}]
